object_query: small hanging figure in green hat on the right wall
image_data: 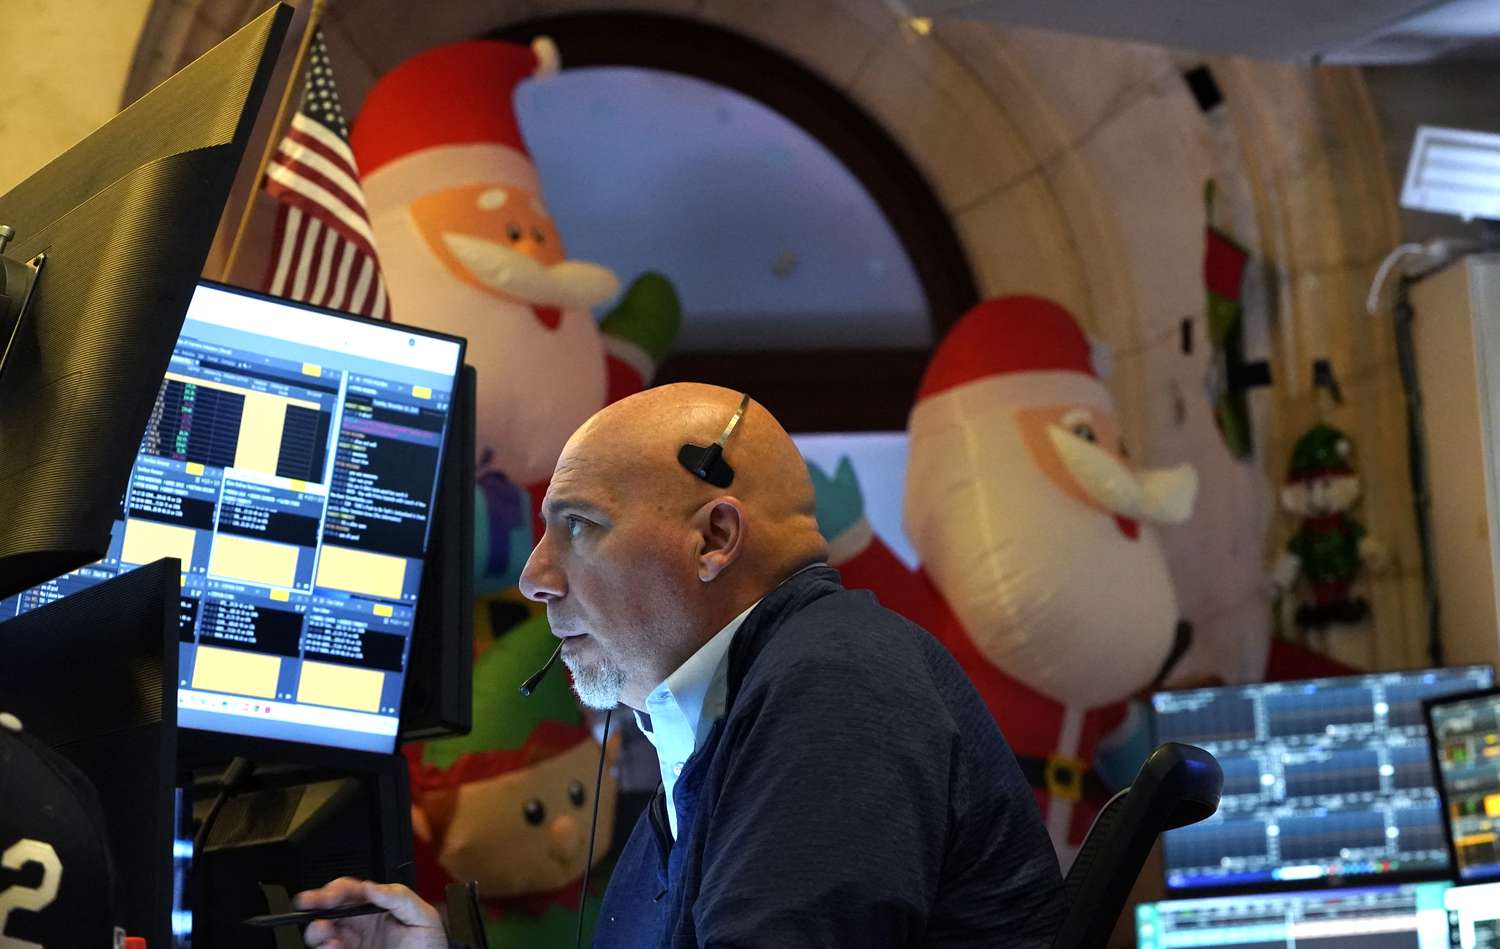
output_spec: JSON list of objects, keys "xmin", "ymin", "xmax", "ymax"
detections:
[{"xmin": 1272, "ymin": 424, "xmax": 1386, "ymax": 630}]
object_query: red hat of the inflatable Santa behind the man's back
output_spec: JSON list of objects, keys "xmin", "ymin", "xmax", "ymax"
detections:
[{"xmin": 917, "ymin": 297, "xmax": 1109, "ymax": 403}]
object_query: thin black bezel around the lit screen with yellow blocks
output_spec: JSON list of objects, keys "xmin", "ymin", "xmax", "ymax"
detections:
[{"xmin": 173, "ymin": 279, "xmax": 468, "ymax": 771}]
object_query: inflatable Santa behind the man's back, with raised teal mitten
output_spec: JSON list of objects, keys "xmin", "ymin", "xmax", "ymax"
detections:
[{"xmin": 815, "ymin": 297, "xmax": 1197, "ymax": 859}]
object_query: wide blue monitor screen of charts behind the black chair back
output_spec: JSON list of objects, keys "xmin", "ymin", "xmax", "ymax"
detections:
[{"xmin": 1152, "ymin": 666, "xmax": 1493, "ymax": 892}]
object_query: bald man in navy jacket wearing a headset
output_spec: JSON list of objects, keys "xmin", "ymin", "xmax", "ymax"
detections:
[{"xmin": 299, "ymin": 384, "xmax": 1065, "ymax": 949}]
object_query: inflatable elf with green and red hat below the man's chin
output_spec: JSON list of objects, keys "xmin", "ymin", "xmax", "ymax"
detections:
[{"xmin": 405, "ymin": 616, "xmax": 618, "ymax": 948}]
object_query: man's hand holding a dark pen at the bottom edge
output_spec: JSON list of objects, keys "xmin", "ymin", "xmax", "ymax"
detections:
[{"xmin": 293, "ymin": 877, "xmax": 449, "ymax": 949}]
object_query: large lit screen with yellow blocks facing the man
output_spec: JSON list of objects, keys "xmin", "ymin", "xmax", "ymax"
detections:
[{"xmin": 0, "ymin": 283, "xmax": 464, "ymax": 753}]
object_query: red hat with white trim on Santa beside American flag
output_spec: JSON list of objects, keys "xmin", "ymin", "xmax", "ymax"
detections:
[{"xmin": 350, "ymin": 37, "xmax": 558, "ymax": 211}]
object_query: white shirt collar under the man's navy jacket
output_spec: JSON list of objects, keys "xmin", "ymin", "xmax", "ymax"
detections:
[{"xmin": 636, "ymin": 600, "xmax": 761, "ymax": 840}]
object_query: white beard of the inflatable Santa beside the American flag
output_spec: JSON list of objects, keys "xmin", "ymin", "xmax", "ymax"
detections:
[{"xmin": 371, "ymin": 207, "xmax": 605, "ymax": 484}]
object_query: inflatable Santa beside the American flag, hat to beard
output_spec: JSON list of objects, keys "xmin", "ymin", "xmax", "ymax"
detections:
[{"xmin": 350, "ymin": 39, "xmax": 677, "ymax": 486}]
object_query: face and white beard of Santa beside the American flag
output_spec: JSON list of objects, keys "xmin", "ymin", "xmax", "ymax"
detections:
[{"xmin": 371, "ymin": 172, "xmax": 618, "ymax": 484}]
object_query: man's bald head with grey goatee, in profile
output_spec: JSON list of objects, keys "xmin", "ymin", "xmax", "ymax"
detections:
[{"xmin": 522, "ymin": 384, "xmax": 828, "ymax": 708}]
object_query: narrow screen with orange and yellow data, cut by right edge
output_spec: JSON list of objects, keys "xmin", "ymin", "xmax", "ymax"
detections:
[{"xmin": 1431, "ymin": 694, "xmax": 1500, "ymax": 880}]
